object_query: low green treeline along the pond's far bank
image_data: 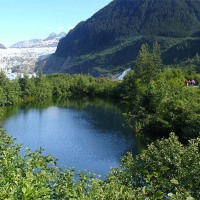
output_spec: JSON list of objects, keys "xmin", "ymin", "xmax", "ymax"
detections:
[{"xmin": 0, "ymin": 72, "xmax": 119, "ymax": 106}]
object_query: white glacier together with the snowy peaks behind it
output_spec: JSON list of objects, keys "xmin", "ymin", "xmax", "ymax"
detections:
[{"xmin": 0, "ymin": 33, "xmax": 66, "ymax": 73}]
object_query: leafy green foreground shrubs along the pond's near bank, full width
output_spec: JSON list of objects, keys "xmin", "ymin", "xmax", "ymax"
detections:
[{"xmin": 0, "ymin": 130, "xmax": 200, "ymax": 200}]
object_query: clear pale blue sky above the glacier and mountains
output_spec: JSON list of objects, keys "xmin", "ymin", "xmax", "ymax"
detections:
[{"xmin": 0, "ymin": 0, "xmax": 112, "ymax": 47}]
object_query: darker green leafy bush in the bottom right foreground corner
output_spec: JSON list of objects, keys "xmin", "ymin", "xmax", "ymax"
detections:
[{"xmin": 111, "ymin": 133, "xmax": 200, "ymax": 199}]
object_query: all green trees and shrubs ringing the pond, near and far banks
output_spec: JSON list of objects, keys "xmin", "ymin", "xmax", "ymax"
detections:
[{"xmin": 0, "ymin": 43, "xmax": 200, "ymax": 200}]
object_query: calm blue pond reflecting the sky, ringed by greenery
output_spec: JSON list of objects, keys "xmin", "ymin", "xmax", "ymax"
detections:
[{"xmin": 0, "ymin": 99, "xmax": 139, "ymax": 176}]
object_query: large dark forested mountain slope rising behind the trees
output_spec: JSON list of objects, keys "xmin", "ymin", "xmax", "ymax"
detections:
[{"xmin": 38, "ymin": 0, "xmax": 200, "ymax": 76}]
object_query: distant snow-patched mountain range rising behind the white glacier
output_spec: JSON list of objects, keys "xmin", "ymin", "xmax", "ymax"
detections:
[{"xmin": 10, "ymin": 32, "xmax": 66, "ymax": 48}]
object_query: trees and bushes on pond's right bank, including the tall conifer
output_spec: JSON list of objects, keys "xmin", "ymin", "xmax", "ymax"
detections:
[{"xmin": 121, "ymin": 46, "xmax": 200, "ymax": 139}]
